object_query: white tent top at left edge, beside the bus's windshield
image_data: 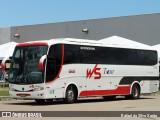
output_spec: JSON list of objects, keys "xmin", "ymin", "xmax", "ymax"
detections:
[{"xmin": 0, "ymin": 42, "xmax": 18, "ymax": 60}]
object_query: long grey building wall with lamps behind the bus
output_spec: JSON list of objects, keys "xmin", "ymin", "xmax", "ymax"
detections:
[{"xmin": 0, "ymin": 13, "xmax": 160, "ymax": 45}]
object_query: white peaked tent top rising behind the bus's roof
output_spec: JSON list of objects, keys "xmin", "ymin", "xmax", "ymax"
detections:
[{"xmin": 99, "ymin": 36, "xmax": 151, "ymax": 48}]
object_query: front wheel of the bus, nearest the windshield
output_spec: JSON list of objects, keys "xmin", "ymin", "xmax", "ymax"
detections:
[{"xmin": 64, "ymin": 85, "xmax": 77, "ymax": 104}]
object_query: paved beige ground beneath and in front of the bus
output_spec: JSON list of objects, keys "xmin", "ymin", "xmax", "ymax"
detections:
[{"xmin": 0, "ymin": 95, "xmax": 160, "ymax": 120}]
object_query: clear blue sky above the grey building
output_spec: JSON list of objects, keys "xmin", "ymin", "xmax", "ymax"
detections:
[{"xmin": 0, "ymin": 0, "xmax": 160, "ymax": 27}]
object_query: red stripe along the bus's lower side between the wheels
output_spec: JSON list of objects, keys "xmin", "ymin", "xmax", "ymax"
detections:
[{"xmin": 79, "ymin": 86, "xmax": 130, "ymax": 96}]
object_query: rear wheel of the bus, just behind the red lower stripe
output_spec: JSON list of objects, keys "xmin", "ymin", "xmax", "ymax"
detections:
[{"xmin": 125, "ymin": 84, "xmax": 140, "ymax": 99}]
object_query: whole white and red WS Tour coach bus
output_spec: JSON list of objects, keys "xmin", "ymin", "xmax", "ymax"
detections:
[{"xmin": 2, "ymin": 38, "xmax": 159, "ymax": 103}]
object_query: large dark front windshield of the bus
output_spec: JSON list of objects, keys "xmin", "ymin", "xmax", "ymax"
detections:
[{"xmin": 8, "ymin": 46, "xmax": 48, "ymax": 84}]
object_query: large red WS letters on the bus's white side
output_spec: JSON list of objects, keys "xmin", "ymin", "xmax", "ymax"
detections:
[{"xmin": 86, "ymin": 64, "xmax": 101, "ymax": 79}]
